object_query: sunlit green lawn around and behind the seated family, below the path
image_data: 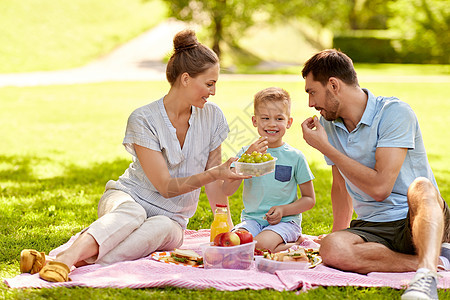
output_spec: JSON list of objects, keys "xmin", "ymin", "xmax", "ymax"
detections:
[{"xmin": 0, "ymin": 77, "xmax": 450, "ymax": 299}]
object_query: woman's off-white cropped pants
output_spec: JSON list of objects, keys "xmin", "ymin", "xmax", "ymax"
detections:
[{"xmin": 85, "ymin": 189, "xmax": 184, "ymax": 265}]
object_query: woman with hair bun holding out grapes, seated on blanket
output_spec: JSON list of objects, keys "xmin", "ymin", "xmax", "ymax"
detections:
[{"xmin": 20, "ymin": 30, "xmax": 248, "ymax": 281}]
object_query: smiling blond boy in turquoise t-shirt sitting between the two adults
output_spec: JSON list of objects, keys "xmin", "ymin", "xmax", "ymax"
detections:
[{"xmin": 223, "ymin": 87, "xmax": 315, "ymax": 252}]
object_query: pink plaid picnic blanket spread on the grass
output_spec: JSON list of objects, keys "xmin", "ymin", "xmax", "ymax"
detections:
[{"xmin": 4, "ymin": 229, "xmax": 450, "ymax": 291}]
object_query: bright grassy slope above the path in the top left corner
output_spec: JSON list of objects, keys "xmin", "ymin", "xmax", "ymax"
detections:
[{"xmin": 0, "ymin": 0, "xmax": 166, "ymax": 73}]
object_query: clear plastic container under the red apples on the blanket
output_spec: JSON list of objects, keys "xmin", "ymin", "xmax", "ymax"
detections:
[{"xmin": 200, "ymin": 241, "xmax": 256, "ymax": 270}]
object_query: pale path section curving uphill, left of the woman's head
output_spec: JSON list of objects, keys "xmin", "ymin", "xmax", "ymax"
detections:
[{"xmin": 0, "ymin": 20, "xmax": 185, "ymax": 87}]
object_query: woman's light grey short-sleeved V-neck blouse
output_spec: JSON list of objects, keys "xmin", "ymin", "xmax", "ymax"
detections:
[{"xmin": 106, "ymin": 98, "xmax": 229, "ymax": 228}]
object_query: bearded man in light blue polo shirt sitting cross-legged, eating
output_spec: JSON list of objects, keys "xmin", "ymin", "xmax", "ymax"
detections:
[{"xmin": 302, "ymin": 50, "xmax": 450, "ymax": 299}]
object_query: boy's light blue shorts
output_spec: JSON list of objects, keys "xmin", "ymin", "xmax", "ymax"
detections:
[{"xmin": 232, "ymin": 220, "xmax": 302, "ymax": 243}]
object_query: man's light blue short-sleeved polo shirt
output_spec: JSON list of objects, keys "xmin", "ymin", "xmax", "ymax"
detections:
[{"xmin": 320, "ymin": 89, "xmax": 437, "ymax": 222}]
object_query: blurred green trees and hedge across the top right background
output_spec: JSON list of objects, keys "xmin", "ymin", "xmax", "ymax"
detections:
[{"xmin": 158, "ymin": 0, "xmax": 450, "ymax": 65}]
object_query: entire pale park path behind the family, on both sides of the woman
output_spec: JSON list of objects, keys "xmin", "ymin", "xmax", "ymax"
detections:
[{"xmin": 0, "ymin": 19, "xmax": 449, "ymax": 87}]
